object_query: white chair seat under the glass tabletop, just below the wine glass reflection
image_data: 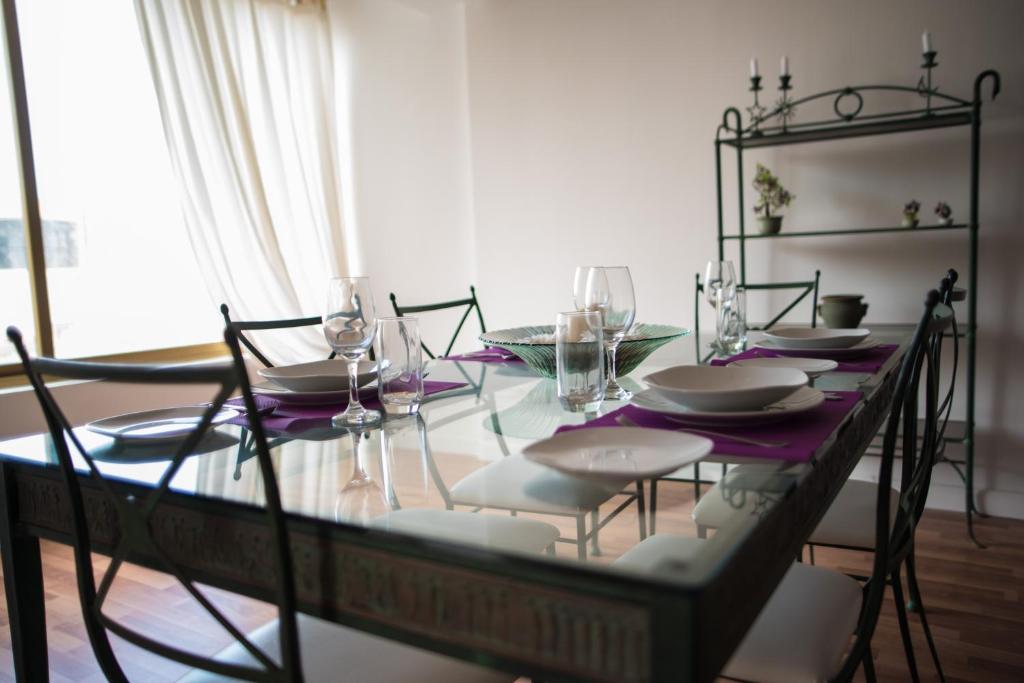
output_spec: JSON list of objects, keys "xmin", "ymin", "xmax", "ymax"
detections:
[{"xmin": 371, "ymin": 509, "xmax": 558, "ymax": 553}]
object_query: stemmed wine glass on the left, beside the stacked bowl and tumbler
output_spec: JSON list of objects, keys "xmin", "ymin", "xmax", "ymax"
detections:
[{"xmin": 324, "ymin": 278, "xmax": 381, "ymax": 427}]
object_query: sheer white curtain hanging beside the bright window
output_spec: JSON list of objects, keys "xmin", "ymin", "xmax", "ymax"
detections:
[{"xmin": 135, "ymin": 0, "xmax": 348, "ymax": 361}]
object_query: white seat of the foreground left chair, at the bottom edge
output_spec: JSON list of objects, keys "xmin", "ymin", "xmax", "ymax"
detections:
[{"xmin": 181, "ymin": 614, "xmax": 516, "ymax": 683}]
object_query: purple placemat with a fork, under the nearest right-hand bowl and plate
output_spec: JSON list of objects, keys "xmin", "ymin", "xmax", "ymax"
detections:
[{"xmin": 557, "ymin": 391, "xmax": 861, "ymax": 463}]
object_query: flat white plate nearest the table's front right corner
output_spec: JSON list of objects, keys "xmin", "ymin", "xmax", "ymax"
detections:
[{"xmin": 522, "ymin": 427, "xmax": 714, "ymax": 480}]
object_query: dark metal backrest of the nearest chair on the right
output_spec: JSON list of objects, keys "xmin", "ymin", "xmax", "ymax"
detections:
[{"xmin": 834, "ymin": 290, "xmax": 952, "ymax": 681}]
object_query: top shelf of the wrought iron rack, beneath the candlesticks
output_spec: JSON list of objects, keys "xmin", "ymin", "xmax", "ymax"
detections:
[{"xmin": 722, "ymin": 108, "xmax": 972, "ymax": 150}]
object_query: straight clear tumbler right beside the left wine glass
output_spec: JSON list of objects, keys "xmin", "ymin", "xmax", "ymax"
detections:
[{"xmin": 377, "ymin": 317, "xmax": 423, "ymax": 415}]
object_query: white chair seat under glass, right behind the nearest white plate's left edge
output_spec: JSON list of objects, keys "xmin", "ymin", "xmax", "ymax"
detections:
[{"xmin": 450, "ymin": 455, "xmax": 622, "ymax": 515}]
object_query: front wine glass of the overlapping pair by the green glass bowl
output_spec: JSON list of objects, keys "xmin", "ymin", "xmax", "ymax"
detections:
[{"xmin": 584, "ymin": 265, "xmax": 636, "ymax": 400}]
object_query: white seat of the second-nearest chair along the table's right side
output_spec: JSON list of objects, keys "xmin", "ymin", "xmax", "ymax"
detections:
[{"xmin": 693, "ymin": 475, "xmax": 899, "ymax": 550}]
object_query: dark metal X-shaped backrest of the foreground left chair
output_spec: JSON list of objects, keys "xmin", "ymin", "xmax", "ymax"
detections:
[{"xmin": 7, "ymin": 328, "xmax": 302, "ymax": 681}]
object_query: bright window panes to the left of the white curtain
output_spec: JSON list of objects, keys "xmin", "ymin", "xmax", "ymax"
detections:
[{"xmin": 0, "ymin": 0, "xmax": 221, "ymax": 374}]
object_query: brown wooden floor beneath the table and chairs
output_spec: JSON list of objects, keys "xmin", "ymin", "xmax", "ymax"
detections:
[{"xmin": 0, "ymin": 499, "xmax": 1024, "ymax": 683}]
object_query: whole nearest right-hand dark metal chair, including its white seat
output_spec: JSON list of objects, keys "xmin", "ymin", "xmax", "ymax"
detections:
[{"xmin": 618, "ymin": 290, "xmax": 952, "ymax": 681}]
